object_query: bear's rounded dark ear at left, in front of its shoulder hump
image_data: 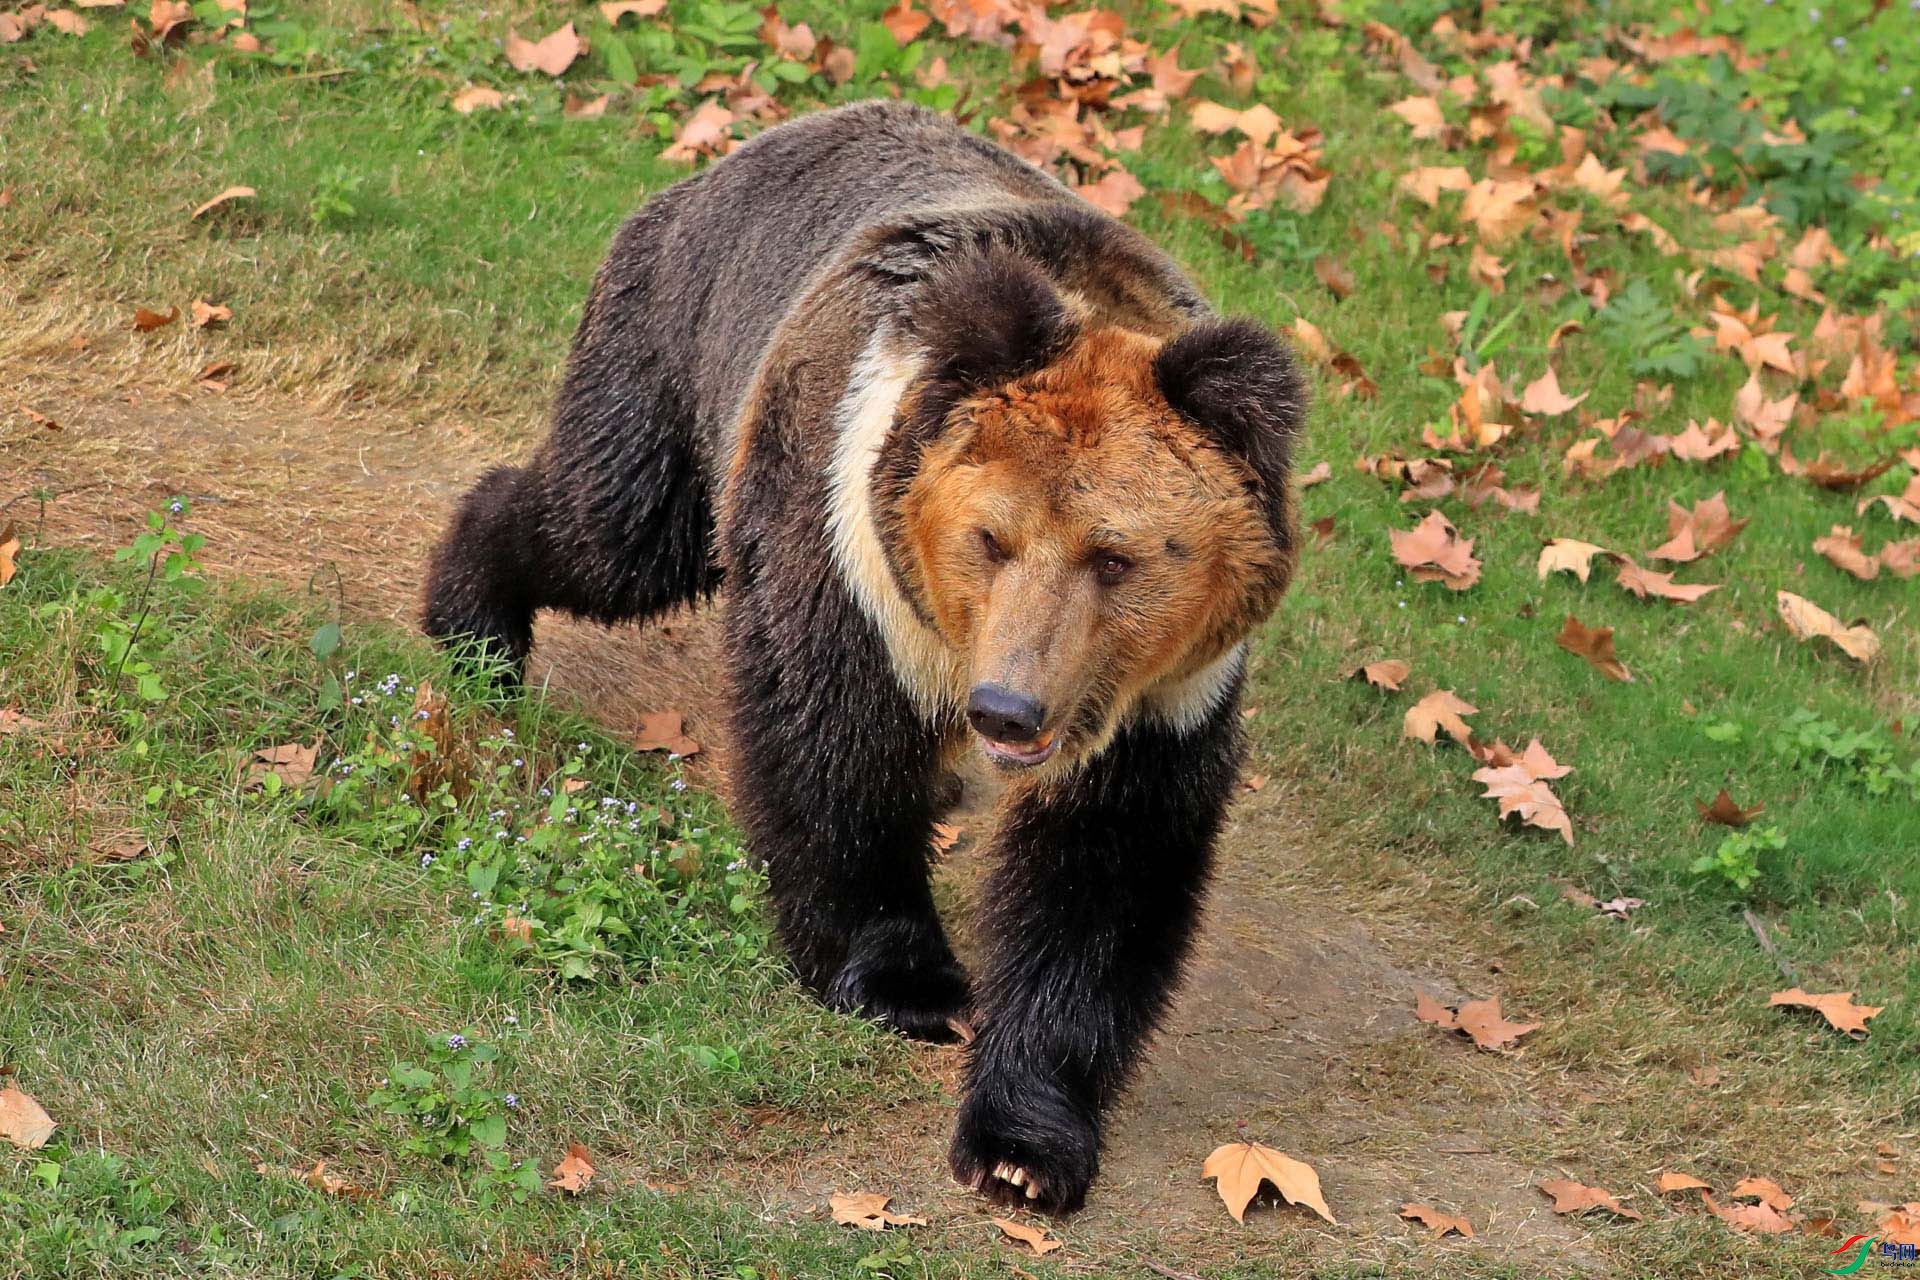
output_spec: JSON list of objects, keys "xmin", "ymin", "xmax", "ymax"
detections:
[{"xmin": 906, "ymin": 246, "xmax": 1077, "ymax": 390}]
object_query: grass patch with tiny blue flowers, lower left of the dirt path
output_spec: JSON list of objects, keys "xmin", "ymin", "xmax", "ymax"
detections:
[{"xmin": 0, "ymin": 555, "xmax": 940, "ymax": 1276}]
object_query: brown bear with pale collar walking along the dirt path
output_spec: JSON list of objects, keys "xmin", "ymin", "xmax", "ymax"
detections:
[{"xmin": 426, "ymin": 102, "xmax": 1306, "ymax": 1211}]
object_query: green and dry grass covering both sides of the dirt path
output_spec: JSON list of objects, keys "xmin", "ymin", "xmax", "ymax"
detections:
[{"xmin": 0, "ymin": 2, "xmax": 1920, "ymax": 1276}]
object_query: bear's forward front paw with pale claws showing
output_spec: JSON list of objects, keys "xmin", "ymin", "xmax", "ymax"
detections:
[{"xmin": 948, "ymin": 1090, "xmax": 1100, "ymax": 1213}]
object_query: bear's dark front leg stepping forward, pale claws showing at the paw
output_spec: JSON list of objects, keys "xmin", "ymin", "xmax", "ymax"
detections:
[{"xmin": 950, "ymin": 697, "xmax": 1242, "ymax": 1213}]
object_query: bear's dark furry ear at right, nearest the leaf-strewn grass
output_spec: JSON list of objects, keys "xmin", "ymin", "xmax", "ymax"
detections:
[{"xmin": 1154, "ymin": 320, "xmax": 1308, "ymax": 541}]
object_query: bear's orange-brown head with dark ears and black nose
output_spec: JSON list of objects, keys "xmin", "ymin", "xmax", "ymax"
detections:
[{"xmin": 874, "ymin": 248, "xmax": 1306, "ymax": 771}]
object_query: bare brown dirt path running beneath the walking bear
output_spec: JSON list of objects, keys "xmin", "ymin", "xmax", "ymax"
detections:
[{"xmin": 0, "ymin": 380, "xmax": 1607, "ymax": 1274}]
